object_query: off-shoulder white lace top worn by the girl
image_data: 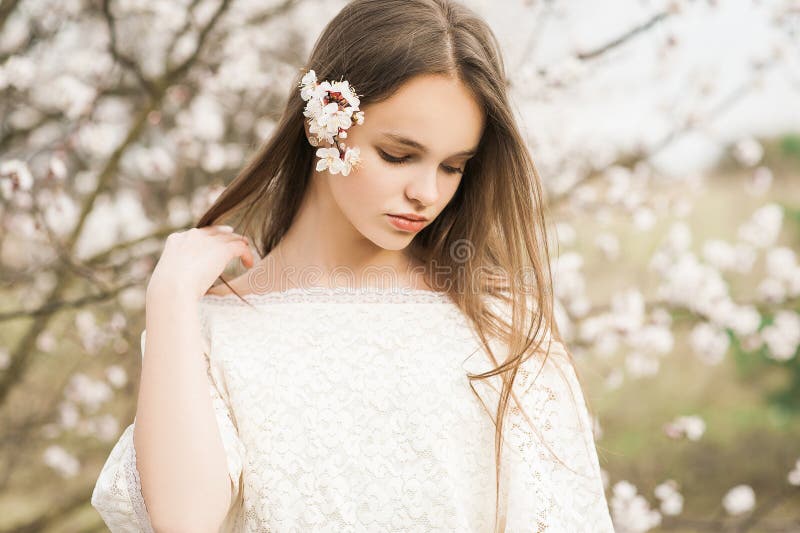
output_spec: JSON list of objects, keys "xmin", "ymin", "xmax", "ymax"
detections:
[{"xmin": 91, "ymin": 289, "xmax": 614, "ymax": 533}]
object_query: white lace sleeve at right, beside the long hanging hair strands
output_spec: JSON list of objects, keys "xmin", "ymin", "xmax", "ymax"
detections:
[{"xmin": 465, "ymin": 339, "xmax": 614, "ymax": 533}]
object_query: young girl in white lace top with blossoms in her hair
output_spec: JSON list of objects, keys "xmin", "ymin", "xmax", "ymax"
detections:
[{"xmin": 92, "ymin": 0, "xmax": 613, "ymax": 533}]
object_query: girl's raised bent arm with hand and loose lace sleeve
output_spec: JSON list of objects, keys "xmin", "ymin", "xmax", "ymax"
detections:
[{"xmin": 92, "ymin": 226, "xmax": 253, "ymax": 533}]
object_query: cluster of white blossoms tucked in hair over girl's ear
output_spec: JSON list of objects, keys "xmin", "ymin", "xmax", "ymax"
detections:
[{"xmin": 299, "ymin": 70, "xmax": 364, "ymax": 176}]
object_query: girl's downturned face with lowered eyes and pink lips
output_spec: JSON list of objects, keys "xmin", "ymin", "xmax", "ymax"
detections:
[{"xmin": 306, "ymin": 75, "xmax": 484, "ymax": 254}]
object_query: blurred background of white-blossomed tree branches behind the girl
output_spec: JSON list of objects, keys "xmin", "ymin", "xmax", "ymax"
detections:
[{"xmin": 0, "ymin": 0, "xmax": 800, "ymax": 532}]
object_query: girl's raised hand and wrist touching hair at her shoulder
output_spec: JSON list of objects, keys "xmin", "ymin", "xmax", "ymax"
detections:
[{"xmin": 147, "ymin": 225, "xmax": 254, "ymax": 300}]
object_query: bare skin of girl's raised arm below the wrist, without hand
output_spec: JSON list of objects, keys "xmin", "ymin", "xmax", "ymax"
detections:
[{"xmin": 133, "ymin": 291, "xmax": 232, "ymax": 531}]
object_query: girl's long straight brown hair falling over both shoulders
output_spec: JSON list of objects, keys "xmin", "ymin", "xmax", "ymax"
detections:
[{"xmin": 197, "ymin": 0, "xmax": 592, "ymax": 529}]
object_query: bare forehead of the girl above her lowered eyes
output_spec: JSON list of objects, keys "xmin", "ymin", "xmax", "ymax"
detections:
[{"xmin": 359, "ymin": 75, "xmax": 484, "ymax": 155}]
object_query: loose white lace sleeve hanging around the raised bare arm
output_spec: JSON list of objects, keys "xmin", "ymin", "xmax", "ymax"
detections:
[{"xmin": 91, "ymin": 319, "xmax": 244, "ymax": 533}]
